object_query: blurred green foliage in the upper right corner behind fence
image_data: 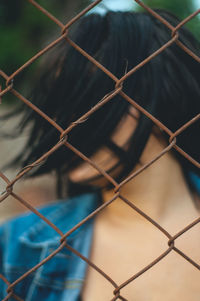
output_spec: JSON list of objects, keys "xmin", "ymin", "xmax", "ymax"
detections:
[{"xmin": 136, "ymin": 0, "xmax": 200, "ymax": 40}]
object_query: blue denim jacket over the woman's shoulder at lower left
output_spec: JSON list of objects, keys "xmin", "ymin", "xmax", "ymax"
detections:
[{"xmin": 0, "ymin": 194, "xmax": 100, "ymax": 301}]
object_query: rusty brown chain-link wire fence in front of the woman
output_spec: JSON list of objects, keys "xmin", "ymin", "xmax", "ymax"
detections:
[{"xmin": 0, "ymin": 0, "xmax": 200, "ymax": 301}]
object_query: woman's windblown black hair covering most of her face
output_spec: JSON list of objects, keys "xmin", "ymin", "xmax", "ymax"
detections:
[{"xmin": 2, "ymin": 10, "xmax": 200, "ymax": 194}]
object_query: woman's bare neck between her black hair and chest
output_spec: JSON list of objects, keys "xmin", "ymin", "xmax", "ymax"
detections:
[{"xmin": 103, "ymin": 153, "xmax": 193, "ymax": 223}]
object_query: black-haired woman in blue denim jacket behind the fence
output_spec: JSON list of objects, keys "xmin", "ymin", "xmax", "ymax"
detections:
[{"xmin": 0, "ymin": 11, "xmax": 200, "ymax": 301}]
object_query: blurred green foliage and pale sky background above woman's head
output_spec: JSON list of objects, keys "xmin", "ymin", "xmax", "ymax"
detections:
[{"xmin": 0, "ymin": 0, "xmax": 200, "ymax": 102}]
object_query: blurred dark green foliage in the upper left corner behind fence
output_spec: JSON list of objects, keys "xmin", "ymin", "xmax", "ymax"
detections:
[{"xmin": 0, "ymin": 0, "xmax": 88, "ymax": 101}]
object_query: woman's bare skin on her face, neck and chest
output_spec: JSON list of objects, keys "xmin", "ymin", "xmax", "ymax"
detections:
[{"xmin": 70, "ymin": 110, "xmax": 200, "ymax": 301}]
